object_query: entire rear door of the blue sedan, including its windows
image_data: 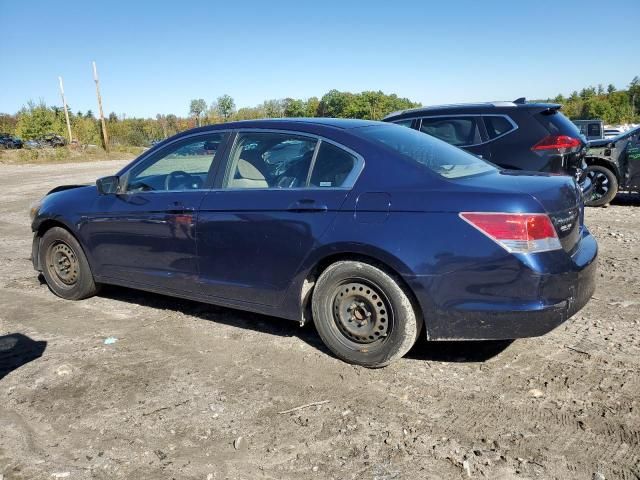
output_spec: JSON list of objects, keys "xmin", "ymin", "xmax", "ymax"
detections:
[{"xmin": 197, "ymin": 130, "xmax": 364, "ymax": 306}]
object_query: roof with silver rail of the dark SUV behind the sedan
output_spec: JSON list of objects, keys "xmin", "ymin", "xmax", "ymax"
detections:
[{"xmin": 383, "ymin": 98, "xmax": 562, "ymax": 121}]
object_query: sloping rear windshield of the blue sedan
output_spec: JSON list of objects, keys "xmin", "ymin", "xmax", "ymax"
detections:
[{"xmin": 357, "ymin": 124, "xmax": 497, "ymax": 178}]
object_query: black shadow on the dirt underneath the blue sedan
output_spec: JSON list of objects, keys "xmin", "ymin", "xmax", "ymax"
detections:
[{"xmin": 100, "ymin": 285, "xmax": 512, "ymax": 362}]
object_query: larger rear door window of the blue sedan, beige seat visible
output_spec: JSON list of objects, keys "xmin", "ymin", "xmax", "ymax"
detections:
[{"xmin": 225, "ymin": 132, "xmax": 318, "ymax": 189}]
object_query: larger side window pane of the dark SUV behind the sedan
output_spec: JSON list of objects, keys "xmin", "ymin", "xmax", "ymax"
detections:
[{"xmin": 417, "ymin": 115, "xmax": 491, "ymax": 160}]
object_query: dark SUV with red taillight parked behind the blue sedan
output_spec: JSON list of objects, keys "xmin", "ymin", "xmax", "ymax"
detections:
[{"xmin": 383, "ymin": 98, "xmax": 590, "ymax": 191}]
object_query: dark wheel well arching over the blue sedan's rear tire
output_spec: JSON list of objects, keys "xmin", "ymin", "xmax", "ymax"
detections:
[{"xmin": 301, "ymin": 253, "xmax": 426, "ymax": 336}]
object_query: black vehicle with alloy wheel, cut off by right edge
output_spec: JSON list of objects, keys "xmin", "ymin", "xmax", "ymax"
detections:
[{"xmin": 586, "ymin": 127, "xmax": 640, "ymax": 207}]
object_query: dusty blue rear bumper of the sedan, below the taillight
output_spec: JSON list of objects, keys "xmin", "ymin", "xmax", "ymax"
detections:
[{"xmin": 410, "ymin": 232, "xmax": 597, "ymax": 340}]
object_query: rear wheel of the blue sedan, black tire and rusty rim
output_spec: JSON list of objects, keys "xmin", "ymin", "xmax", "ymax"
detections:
[{"xmin": 311, "ymin": 261, "xmax": 422, "ymax": 368}]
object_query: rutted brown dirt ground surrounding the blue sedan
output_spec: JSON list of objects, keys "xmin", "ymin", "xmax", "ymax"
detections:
[{"xmin": 0, "ymin": 162, "xmax": 640, "ymax": 480}]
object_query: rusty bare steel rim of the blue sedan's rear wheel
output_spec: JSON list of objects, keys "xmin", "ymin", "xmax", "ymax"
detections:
[{"xmin": 331, "ymin": 279, "xmax": 394, "ymax": 350}]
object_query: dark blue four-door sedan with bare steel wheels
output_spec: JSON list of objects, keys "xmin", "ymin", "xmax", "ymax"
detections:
[{"xmin": 31, "ymin": 120, "xmax": 597, "ymax": 367}]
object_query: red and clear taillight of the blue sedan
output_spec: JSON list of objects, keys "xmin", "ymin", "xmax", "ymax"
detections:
[{"xmin": 460, "ymin": 212, "xmax": 562, "ymax": 253}]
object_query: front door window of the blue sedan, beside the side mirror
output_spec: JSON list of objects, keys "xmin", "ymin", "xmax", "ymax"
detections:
[{"xmin": 125, "ymin": 133, "xmax": 224, "ymax": 192}]
